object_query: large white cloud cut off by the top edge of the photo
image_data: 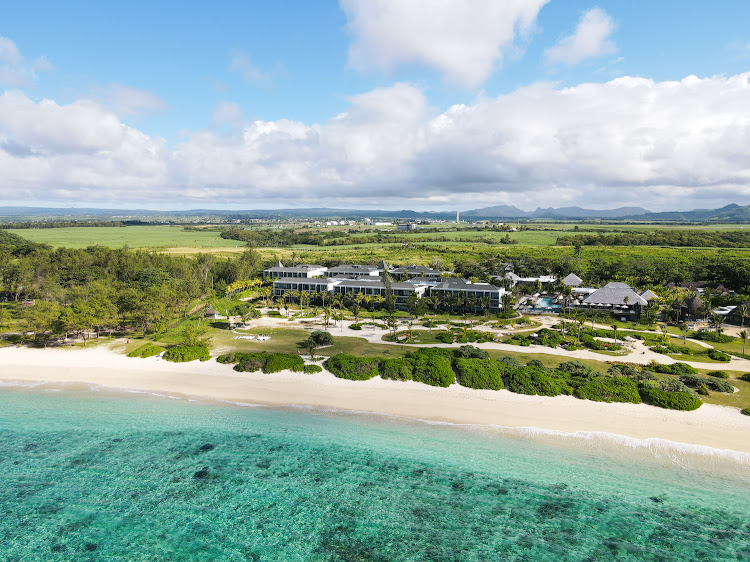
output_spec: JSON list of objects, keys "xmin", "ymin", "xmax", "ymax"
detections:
[{"xmin": 340, "ymin": 0, "xmax": 549, "ymax": 87}]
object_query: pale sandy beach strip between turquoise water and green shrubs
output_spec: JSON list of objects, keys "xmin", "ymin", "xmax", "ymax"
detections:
[{"xmin": 0, "ymin": 346, "xmax": 750, "ymax": 453}]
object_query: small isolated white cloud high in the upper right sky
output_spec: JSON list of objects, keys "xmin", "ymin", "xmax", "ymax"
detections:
[{"xmin": 544, "ymin": 8, "xmax": 617, "ymax": 66}]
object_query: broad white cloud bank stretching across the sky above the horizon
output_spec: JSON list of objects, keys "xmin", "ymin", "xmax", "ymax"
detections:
[{"xmin": 5, "ymin": 73, "xmax": 750, "ymax": 210}]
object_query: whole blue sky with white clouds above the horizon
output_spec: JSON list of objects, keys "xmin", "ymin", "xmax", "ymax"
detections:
[{"xmin": 0, "ymin": 0, "xmax": 750, "ymax": 211}]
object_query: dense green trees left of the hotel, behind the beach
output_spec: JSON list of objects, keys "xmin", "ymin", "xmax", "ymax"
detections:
[{"xmin": 0, "ymin": 241, "xmax": 264, "ymax": 341}]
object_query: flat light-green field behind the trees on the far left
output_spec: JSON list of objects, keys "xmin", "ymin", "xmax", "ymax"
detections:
[{"xmin": 10, "ymin": 226, "xmax": 245, "ymax": 252}]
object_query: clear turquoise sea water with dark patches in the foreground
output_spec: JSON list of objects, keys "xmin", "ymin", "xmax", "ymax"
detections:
[{"xmin": 0, "ymin": 386, "xmax": 750, "ymax": 561}]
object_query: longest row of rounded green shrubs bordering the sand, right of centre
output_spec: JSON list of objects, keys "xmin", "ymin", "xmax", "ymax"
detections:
[{"xmin": 324, "ymin": 345, "xmax": 704, "ymax": 410}]
